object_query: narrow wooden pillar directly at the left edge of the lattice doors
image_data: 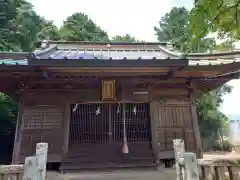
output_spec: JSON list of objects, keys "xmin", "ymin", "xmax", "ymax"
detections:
[{"xmin": 63, "ymin": 103, "xmax": 71, "ymax": 154}]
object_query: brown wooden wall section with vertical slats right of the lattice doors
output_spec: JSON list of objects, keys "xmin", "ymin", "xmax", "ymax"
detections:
[{"xmin": 151, "ymin": 96, "xmax": 195, "ymax": 158}]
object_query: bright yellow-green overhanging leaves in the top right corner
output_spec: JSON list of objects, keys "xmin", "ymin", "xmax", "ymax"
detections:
[{"xmin": 190, "ymin": 0, "xmax": 240, "ymax": 40}]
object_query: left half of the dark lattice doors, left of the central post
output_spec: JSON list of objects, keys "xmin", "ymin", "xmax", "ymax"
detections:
[{"xmin": 69, "ymin": 104, "xmax": 109, "ymax": 145}]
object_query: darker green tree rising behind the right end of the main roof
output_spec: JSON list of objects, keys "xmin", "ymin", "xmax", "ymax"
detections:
[{"xmin": 154, "ymin": 7, "xmax": 216, "ymax": 53}]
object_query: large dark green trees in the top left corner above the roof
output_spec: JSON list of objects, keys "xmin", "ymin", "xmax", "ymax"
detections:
[{"xmin": 0, "ymin": 0, "xmax": 60, "ymax": 51}]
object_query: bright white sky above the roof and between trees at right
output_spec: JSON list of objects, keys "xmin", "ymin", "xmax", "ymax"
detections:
[{"xmin": 29, "ymin": 0, "xmax": 240, "ymax": 119}]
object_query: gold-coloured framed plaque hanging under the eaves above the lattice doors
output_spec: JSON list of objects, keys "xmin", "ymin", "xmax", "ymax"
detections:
[{"xmin": 102, "ymin": 80, "xmax": 116, "ymax": 100}]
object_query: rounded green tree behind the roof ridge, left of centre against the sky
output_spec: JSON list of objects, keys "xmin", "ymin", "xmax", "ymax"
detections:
[{"xmin": 60, "ymin": 13, "xmax": 109, "ymax": 41}]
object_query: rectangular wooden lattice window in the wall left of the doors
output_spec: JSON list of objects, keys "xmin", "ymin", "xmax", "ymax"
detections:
[{"xmin": 22, "ymin": 108, "xmax": 63, "ymax": 130}]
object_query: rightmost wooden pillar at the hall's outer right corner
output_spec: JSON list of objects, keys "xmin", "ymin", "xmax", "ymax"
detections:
[{"xmin": 188, "ymin": 83, "xmax": 202, "ymax": 158}]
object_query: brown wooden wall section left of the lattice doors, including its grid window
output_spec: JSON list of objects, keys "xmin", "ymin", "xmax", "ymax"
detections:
[{"xmin": 19, "ymin": 106, "xmax": 64, "ymax": 162}]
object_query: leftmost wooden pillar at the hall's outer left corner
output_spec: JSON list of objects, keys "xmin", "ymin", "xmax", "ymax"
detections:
[{"xmin": 12, "ymin": 104, "xmax": 23, "ymax": 164}]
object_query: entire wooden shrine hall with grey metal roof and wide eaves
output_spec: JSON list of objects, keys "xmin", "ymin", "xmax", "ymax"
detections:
[{"xmin": 0, "ymin": 41, "xmax": 240, "ymax": 171}]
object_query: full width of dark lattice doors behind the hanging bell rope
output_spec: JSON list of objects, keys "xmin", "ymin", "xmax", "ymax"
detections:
[{"xmin": 69, "ymin": 103, "xmax": 151, "ymax": 146}]
